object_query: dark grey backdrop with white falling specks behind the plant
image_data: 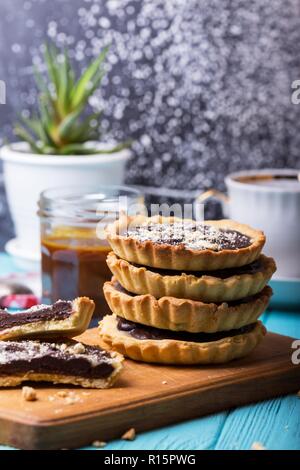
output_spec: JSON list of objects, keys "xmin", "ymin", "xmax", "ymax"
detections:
[{"xmin": 0, "ymin": 0, "xmax": 300, "ymax": 248}]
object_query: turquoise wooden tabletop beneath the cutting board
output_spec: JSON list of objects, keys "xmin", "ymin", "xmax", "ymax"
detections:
[{"xmin": 0, "ymin": 254, "xmax": 300, "ymax": 450}]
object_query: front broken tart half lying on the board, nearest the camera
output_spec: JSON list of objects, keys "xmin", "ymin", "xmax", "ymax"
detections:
[{"xmin": 0, "ymin": 340, "xmax": 123, "ymax": 388}]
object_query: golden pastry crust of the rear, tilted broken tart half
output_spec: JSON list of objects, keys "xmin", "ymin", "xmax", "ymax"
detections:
[{"xmin": 0, "ymin": 297, "xmax": 95, "ymax": 341}]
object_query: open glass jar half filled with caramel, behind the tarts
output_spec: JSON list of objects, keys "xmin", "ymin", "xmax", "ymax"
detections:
[{"xmin": 39, "ymin": 186, "xmax": 143, "ymax": 317}]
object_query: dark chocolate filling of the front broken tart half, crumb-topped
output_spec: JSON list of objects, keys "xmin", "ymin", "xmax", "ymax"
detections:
[{"xmin": 0, "ymin": 340, "xmax": 114, "ymax": 379}]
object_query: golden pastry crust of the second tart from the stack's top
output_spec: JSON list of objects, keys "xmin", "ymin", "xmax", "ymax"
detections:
[{"xmin": 107, "ymin": 252, "xmax": 276, "ymax": 302}]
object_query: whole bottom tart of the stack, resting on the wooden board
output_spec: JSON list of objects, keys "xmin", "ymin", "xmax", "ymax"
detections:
[{"xmin": 99, "ymin": 315, "xmax": 266, "ymax": 365}]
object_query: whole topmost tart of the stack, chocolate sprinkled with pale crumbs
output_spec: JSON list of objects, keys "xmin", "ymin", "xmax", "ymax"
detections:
[{"xmin": 106, "ymin": 215, "xmax": 265, "ymax": 271}]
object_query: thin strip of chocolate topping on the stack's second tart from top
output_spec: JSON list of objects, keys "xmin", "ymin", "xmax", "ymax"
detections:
[{"xmin": 135, "ymin": 258, "xmax": 263, "ymax": 279}]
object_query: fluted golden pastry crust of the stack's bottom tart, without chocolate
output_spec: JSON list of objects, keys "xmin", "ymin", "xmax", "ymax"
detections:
[{"xmin": 99, "ymin": 315, "xmax": 266, "ymax": 365}]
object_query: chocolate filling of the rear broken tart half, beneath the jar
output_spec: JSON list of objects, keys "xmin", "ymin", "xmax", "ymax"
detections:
[{"xmin": 0, "ymin": 300, "xmax": 73, "ymax": 331}]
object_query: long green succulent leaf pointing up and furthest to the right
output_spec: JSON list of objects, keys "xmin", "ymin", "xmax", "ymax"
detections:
[{"xmin": 71, "ymin": 47, "xmax": 108, "ymax": 109}]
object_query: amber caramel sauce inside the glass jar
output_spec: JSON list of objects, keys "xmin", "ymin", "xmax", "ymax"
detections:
[{"xmin": 41, "ymin": 230, "xmax": 111, "ymax": 316}]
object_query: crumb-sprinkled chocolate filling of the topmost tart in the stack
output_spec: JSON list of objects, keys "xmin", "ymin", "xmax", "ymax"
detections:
[{"xmin": 123, "ymin": 222, "xmax": 251, "ymax": 251}]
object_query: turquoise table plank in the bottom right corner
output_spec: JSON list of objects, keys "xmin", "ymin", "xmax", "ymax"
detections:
[{"xmin": 215, "ymin": 396, "xmax": 300, "ymax": 450}]
